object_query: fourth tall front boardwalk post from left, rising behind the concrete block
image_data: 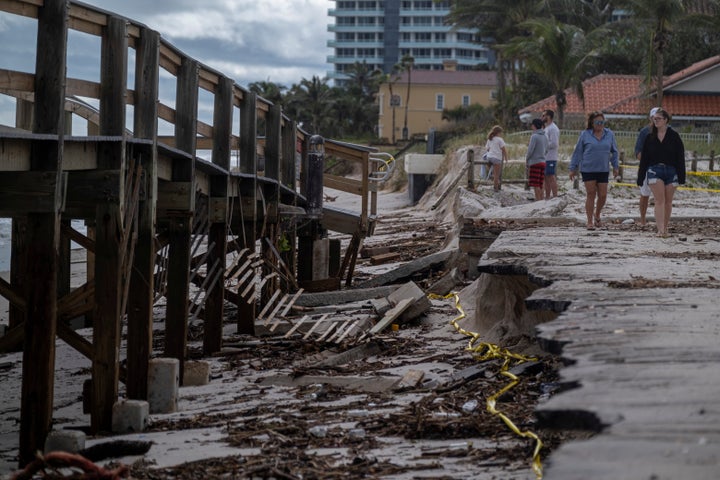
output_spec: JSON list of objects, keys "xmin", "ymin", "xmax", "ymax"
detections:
[{"xmin": 165, "ymin": 57, "xmax": 200, "ymax": 382}]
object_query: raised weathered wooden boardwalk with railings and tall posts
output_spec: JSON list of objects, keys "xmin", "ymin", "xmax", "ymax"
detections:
[{"xmin": 0, "ymin": 0, "xmax": 391, "ymax": 465}]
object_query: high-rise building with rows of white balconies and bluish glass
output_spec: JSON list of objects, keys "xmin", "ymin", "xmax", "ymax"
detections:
[{"xmin": 328, "ymin": 0, "xmax": 491, "ymax": 85}]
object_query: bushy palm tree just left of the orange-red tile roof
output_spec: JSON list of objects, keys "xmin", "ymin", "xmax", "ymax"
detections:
[{"xmin": 501, "ymin": 19, "xmax": 595, "ymax": 126}]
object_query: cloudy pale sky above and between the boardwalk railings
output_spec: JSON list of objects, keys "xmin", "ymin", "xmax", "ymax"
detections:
[{"xmin": 0, "ymin": 0, "xmax": 334, "ymax": 87}]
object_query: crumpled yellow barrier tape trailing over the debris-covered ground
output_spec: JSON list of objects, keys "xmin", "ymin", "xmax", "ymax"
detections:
[{"xmin": 428, "ymin": 292, "xmax": 543, "ymax": 480}]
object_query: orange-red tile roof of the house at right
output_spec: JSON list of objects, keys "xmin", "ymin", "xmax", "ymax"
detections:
[{"xmin": 518, "ymin": 55, "xmax": 720, "ymax": 117}]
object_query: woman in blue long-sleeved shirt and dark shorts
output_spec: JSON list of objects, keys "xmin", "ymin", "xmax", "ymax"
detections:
[{"xmin": 570, "ymin": 112, "xmax": 619, "ymax": 230}]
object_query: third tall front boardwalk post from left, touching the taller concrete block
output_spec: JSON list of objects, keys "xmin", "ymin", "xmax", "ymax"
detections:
[{"xmin": 125, "ymin": 27, "xmax": 160, "ymax": 400}]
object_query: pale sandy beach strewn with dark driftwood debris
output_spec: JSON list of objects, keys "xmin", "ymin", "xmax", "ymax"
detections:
[{"xmin": 0, "ymin": 151, "xmax": 720, "ymax": 480}]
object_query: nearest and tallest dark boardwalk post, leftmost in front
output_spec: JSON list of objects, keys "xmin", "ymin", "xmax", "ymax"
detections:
[{"xmin": 19, "ymin": 0, "xmax": 69, "ymax": 467}]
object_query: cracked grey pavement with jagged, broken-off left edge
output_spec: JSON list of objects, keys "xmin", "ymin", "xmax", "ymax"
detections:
[{"xmin": 480, "ymin": 227, "xmax": 720, "ymax": 480}]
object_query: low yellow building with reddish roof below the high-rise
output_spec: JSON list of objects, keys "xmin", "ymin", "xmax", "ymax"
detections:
[{"xmin": 378, "ymin": 70, "xmax": 497, "ymax": 142}]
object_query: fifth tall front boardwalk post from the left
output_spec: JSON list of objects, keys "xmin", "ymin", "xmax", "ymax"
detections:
[{"xmin": 203, "ymin": 77, "xmax": 234, "ymax": 355}]
